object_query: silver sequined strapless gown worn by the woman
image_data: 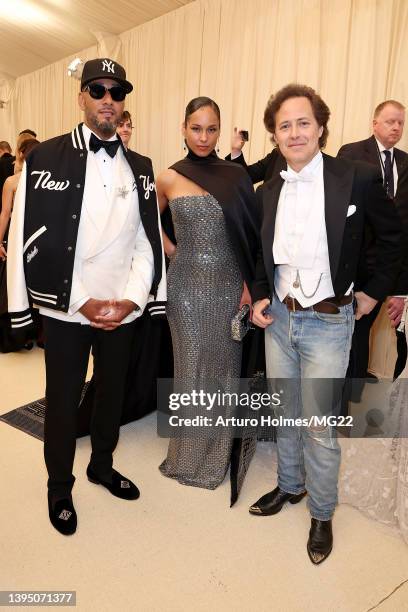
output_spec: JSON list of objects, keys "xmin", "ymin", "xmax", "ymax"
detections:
[{"xmin": 160, "ymin": 195, "xmax": 242, "ymax": 489}]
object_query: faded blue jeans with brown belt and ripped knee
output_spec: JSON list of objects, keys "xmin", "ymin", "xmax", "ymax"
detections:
[{"xmin": 265, "ymin": 295, "xmax": 354, "ymax": 521}]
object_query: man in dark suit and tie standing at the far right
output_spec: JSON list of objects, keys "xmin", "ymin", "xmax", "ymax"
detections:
[{"xmin": 338, "ymin": 100, "xmax": 408, "ymax": 379}]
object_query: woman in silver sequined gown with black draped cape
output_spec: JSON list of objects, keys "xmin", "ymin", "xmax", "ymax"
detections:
[{"xmin": 156, "ymin": 97, "xmax": 257, "ymax": 489}]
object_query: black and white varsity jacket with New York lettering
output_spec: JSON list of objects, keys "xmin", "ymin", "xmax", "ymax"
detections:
[{"xmin": 7, "ymin": 123, "xmax": 166, "ymax": 329}]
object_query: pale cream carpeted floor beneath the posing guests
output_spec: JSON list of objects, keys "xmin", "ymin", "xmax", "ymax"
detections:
[{"xmin": 0, "ymin": 350, "xmax": 408, "ymax": 612}]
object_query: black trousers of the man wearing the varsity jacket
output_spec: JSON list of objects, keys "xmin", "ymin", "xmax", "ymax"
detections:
[{"xmin": 44, "ymin": 317, "xmax": 135, "ymax": 500}]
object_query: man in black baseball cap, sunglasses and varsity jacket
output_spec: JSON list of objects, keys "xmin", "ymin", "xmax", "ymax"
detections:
[{"xmin": 8, "ymin": 58, "xmax": 165, "ymax": 535}]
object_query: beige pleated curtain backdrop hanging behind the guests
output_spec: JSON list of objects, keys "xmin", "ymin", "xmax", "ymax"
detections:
[{"xmin": 0, "ymin": 0, "xmax": 408, "ymax": 376}]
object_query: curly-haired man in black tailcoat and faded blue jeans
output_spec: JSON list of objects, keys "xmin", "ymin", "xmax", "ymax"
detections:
[{"xmin": 250, "ymin": 84, "xmax": 400, "ymax": 564}]
